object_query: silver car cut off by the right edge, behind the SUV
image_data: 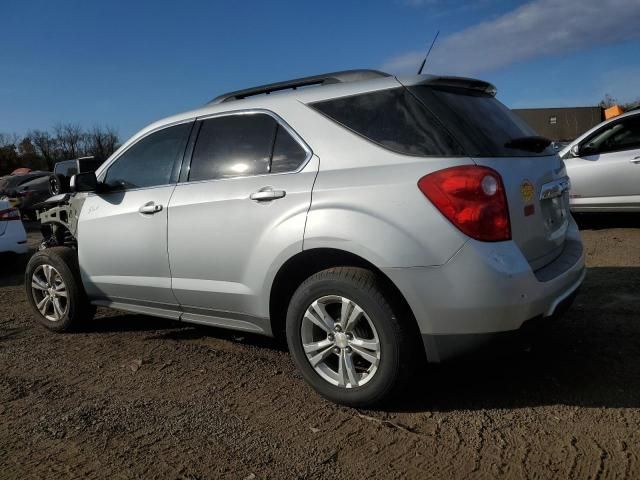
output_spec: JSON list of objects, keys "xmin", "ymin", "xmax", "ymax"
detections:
[{"xmin": 560, "ymin": 110, "xmax": 640, "ymax": 212}]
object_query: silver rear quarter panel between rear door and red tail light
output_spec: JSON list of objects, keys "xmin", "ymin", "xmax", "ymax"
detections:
[{"xmin": 295, "ymin": 107, "xmax": 473, "ymax": 268}]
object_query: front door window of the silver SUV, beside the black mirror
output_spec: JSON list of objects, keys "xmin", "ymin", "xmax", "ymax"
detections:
[{"xmin": 104, "ymin": 123, "xmax": 192, "ymax": 189}]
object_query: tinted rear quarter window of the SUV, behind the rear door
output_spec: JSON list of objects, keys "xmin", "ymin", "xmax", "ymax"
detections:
[{"xmin": 311, "ymin": 87, "xmax": 464, "ymax": 156}]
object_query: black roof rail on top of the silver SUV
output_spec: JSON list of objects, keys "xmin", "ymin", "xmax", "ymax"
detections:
[{"xmin": 209, "ymin": 70, "xmax": 391, "ymax": 104}]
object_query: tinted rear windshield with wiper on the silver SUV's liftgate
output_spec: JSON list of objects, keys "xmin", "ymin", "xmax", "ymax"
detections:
[{"xmin": 409, "ymin": 85, "xmax": 553, "ymax": 157}]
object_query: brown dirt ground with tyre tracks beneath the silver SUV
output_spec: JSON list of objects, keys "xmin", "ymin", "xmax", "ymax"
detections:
[{"xmin": 0, "ymin": 216, "xmax": 640, "ymax": 479}]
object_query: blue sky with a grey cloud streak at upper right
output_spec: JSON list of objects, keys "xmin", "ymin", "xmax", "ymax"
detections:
[{"xmin": 0, "ymin": 0, "xmax": 640, "ymax": 139}]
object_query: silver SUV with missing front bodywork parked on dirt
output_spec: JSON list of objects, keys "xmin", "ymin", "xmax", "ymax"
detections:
[{"xmin": 26, "ymin": 70, "xmax": 585, "ymax": 406}]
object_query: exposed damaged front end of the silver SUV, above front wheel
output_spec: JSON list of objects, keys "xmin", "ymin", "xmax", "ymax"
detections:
[{"xmin": 36, "ymin": 193, "xmax": 85, "ymax": 250}]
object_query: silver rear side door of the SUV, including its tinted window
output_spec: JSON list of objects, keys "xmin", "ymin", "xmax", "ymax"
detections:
[{"xmin": 168, "ymin": 111, "xmax": 318, "ymax": 331}]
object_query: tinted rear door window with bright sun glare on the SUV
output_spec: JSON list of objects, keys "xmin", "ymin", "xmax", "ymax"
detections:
[{"xmin": 189, "ymin": 113, "xmax": 278, "ymax": 181}]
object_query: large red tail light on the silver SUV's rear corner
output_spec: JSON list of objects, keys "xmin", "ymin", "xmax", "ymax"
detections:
[{"xmin": 418, "ymin": 165, "xmax": 511, "ymax": 242}]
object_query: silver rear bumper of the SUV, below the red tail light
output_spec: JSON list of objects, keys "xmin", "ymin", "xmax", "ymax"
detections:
[{"xmin": 384, "ymin": 222, "xmax": 586, "ymax": 362}]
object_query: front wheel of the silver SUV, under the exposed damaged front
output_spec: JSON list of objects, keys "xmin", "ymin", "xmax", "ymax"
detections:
[{"xmin": 25, "ymin": 247, "xmax": 95, "ymax": 332}]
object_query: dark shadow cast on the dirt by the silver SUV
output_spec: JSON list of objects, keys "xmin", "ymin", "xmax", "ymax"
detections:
[{"xmin": 79, "ymin": 267, "xmax": 640, "ymax": 412}]
